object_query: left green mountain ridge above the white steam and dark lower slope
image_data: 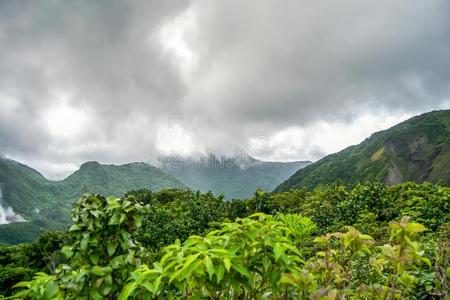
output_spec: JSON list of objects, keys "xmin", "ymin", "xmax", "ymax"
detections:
[{"xmin": 0, "ymin": 159, "xmax": 187, "ymax": 217}]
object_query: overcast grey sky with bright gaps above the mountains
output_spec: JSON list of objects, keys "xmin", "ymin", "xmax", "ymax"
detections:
[{"xmin": 0, "ymin": 0, "xmax": 450, "ymax": 178}]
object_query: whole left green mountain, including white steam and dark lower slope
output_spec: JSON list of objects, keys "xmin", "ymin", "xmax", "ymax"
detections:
[{"xmin": 0, "ymin": 158, "xmax": 187, "ymax": 243}]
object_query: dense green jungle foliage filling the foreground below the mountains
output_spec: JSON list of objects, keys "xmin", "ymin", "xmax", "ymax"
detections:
[{"xmin": 0, "ymin": 182, "xmax": 450, "ymax": 299}]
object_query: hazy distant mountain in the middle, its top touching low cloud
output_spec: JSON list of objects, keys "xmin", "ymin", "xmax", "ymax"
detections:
[{"xmin": 158, "ymin": 154, "xmax": 311, "ymax": 199}]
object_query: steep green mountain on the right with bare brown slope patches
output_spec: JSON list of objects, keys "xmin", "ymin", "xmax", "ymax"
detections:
[{"xmin": 275, "ymin": 110, "xmax": 450, "ymax": 192}]
